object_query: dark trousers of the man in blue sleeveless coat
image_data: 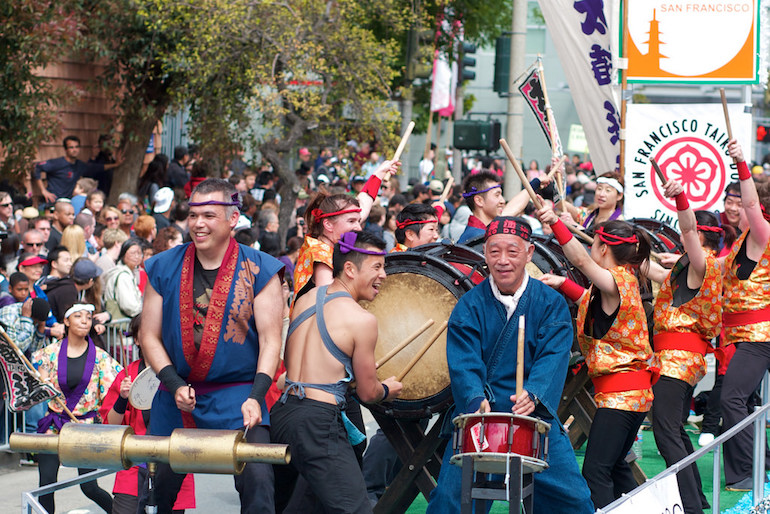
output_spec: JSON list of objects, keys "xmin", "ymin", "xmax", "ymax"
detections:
[{"xmin": 137, "ymin": 426, "xmax": 274, "ymax": 514}]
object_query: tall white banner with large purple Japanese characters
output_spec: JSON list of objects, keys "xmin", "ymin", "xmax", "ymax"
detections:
[{"xmin": 538, "ymin": 0, "xmax": 620, "ymax": 173}]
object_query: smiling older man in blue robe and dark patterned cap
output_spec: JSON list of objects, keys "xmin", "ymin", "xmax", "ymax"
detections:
[{"xmin": 428, "ymin": 217, "xmax": 594, "ymax": 514}]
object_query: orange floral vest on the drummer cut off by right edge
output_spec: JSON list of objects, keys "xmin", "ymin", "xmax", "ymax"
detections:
[{"xmin": 722, "ymin": 231, "xmax": 770, "ymax": 344}]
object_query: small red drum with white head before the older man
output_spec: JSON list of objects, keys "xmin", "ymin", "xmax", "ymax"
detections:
[{"xmin": 450, "ymin": 412, "xmax": 551, "ymax": 474}]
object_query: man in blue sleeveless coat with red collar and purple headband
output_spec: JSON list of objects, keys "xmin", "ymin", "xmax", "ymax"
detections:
[{"xmin": 140, "ymin": 179, "xmax": 284, "ymax": 514}]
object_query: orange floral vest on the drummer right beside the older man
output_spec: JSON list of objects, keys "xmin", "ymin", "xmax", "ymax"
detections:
[{"xmin": 577, "ymin": 266, "xmax": 653, "ymax": 412}]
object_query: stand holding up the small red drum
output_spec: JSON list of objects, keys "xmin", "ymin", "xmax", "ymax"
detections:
[{"xmin": 460, "ymin": 453, "xmax": 535, "ymax": 514}]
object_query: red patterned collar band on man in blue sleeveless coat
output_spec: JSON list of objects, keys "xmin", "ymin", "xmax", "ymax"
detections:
[{"xmin": 179, "ymin": 238, "xmax": 238, "ymax": 428}]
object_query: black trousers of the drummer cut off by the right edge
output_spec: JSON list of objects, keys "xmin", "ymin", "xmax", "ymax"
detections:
[{"xmin": 722, "ymin": 343, "xmax": 770, "ymax": 484}]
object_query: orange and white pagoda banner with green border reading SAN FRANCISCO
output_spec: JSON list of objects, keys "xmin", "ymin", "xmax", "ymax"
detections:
[{"xmin": 623, "ymin": 0, "xmax": 759, "ymax": 84}]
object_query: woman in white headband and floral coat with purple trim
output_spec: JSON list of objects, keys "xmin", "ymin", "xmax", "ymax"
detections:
[{"xmin": 32, "ymin": 303, "xmax": 123, "ymax": 512}]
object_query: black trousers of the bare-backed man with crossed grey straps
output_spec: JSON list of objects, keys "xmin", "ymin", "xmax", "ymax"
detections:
[{"xmin": 270, "ymin": 395, "xmax": 372, "ymax": 514}]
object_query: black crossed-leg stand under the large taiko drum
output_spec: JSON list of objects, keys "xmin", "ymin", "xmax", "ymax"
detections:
[{"xmin": 371, "ymin": 411, "xmax": 448, "ymax": 514}]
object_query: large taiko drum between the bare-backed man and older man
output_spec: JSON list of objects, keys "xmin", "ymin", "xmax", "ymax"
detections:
[{"xmin": 361, "ymin": 243, "xmax": 487, "ymax": 419}]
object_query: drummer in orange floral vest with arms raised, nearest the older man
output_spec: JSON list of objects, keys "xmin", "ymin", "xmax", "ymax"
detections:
[{"xmin": 538, "ymin": 207, "xmax": 655, "ymax": 508}]
